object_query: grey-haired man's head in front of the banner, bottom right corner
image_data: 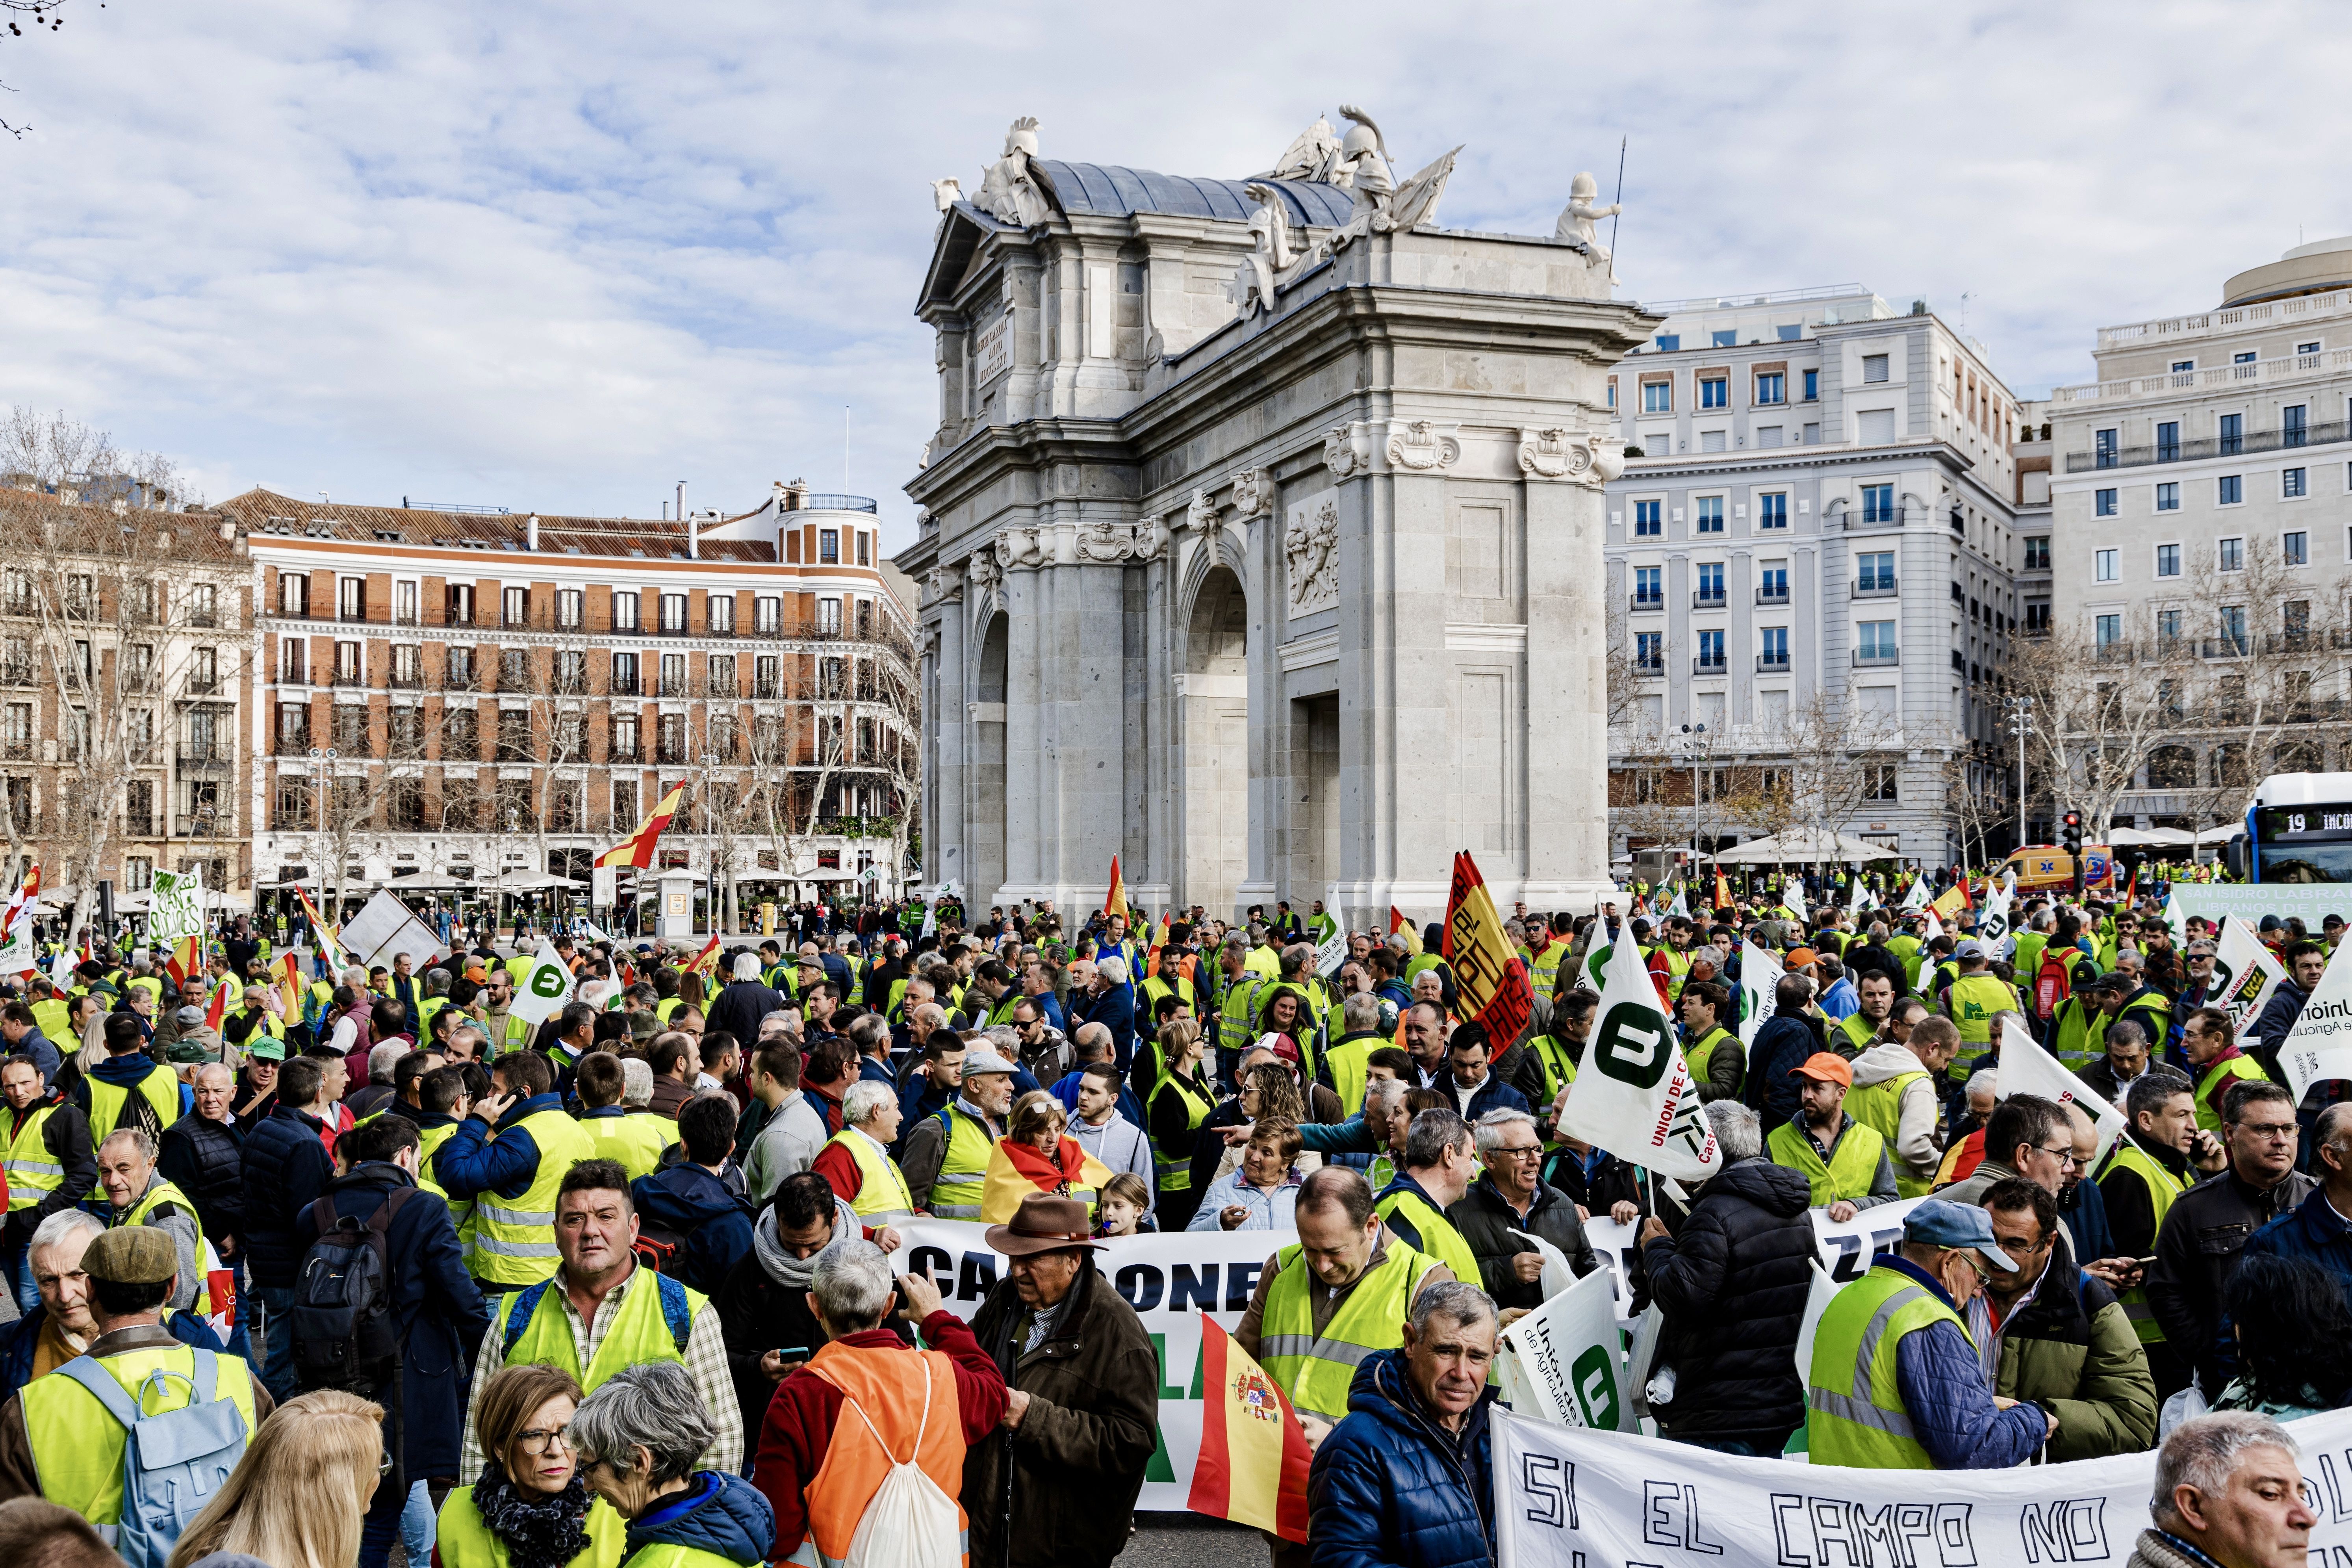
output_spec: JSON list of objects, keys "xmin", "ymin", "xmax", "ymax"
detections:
[{"xmin": 2126, "ymin": 1410, "xmax": 2319, "ymax": 1568}]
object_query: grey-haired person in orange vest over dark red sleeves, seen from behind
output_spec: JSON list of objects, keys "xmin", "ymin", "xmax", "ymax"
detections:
[{"xmin": 753, "ymin": 1241, "xmax": 1004, "ymax": 1561}]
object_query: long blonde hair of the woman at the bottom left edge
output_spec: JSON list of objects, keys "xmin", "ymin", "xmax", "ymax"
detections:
[{"xmin": 167, "ymin": 1389, "xmax": 393, "ymax": 1568}]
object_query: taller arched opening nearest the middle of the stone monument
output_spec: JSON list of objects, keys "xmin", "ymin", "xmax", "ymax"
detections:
[{"xmin": 1181, "ymin": 566, "xmax": 1249, "ymax": 919}]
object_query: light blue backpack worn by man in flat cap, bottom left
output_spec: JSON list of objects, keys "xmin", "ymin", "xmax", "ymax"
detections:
[{"xmin": 56, "ymin": 1349, "xmax": 252, "ymax": 1568}]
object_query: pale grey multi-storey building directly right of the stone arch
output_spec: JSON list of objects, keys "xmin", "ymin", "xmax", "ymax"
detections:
[{"xmin": 1606, "ymin": 284, "xmax": 2020, "ymax": 863}]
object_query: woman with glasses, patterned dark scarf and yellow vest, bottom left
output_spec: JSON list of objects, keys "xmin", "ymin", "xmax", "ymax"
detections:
[{"xmin": 433, "ymin": 1366, "xmax": 628, "ymax": 1568}]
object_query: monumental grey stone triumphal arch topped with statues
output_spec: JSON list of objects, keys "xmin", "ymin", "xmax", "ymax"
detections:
[{"xmin": 898, "ymin": 120, "xmax": 1649, "ymax": 919}]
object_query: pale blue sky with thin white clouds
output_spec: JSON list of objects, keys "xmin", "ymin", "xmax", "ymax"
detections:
[{"xmin": 0, "ymin": 0, "xmax": 2352, "ymax": 548}]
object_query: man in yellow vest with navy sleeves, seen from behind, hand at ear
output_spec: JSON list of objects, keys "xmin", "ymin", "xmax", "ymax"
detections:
[{"xmin": 433, "ymin": 1051, "xmax": 595, "ymax": 1295}]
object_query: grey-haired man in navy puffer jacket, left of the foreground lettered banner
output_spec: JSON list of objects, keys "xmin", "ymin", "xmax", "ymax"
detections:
[{"xmin": 1308, "ymin": 1279, "xmax": 1498, "ymax": 1568}]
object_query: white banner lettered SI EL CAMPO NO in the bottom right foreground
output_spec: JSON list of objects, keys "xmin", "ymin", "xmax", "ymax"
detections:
[{"xmin": 1493, "ymin": 1410, "xmax": 2352, "ymax": 1568}]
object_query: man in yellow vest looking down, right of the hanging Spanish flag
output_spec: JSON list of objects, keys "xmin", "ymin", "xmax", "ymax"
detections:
[{"xmin": 1232, "ymin": 1166, "xmax": 1454, "ymax": 1444}]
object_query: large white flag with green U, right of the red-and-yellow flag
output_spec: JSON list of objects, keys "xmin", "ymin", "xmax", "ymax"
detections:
[{"xmin": 1559, "ymin": 921, "xmax": 1724, "ymax": 1180}]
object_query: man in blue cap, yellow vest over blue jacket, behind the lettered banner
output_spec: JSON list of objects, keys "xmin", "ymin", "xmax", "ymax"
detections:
[{"xmin": 1806, "ymin": 1199, "xmax": 2058, "ymax": 1469}]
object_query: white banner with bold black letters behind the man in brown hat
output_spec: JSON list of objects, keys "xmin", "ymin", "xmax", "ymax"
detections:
[{"xmin": 891, "ymin": 1220, "xmax": 1298, "ymax": 1514}]
